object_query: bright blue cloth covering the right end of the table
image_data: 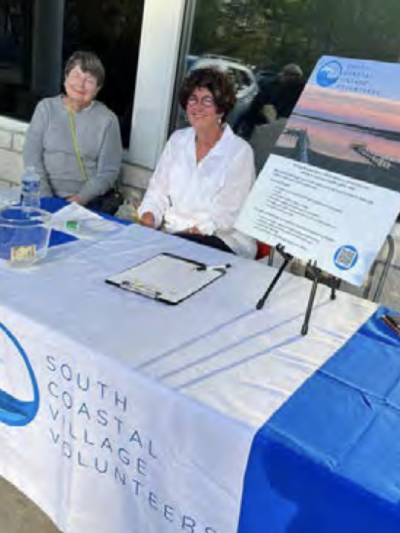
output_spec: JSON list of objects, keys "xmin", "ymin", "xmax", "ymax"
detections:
[{"xmin": 238, "ymin": 308, "xmax": 400, "ymax": 533}]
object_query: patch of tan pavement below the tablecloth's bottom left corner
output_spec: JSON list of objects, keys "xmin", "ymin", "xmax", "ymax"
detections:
[{"xmin": 0, "ymin": 477, "xmax": 60, "ymax": 533}]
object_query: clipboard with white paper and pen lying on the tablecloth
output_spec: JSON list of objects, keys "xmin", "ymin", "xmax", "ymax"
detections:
[{"xmin": 105, "ymin": 253, "xmax": 230, "ymax": 305}]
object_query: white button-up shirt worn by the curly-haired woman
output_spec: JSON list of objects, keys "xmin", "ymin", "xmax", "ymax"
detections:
[{"xmin": 139, "ymin": 125, "xmax": 256, "ymax": 257}]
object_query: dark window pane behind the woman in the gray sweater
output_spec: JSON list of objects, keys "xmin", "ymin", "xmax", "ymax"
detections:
[{"xmin": 0, "ymin": 0, "xmax": 145, "ymax": 146}]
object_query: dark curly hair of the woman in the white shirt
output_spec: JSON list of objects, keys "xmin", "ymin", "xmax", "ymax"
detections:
[{"xmin": 179, "ymin": 68, "xmax": 236, "ymax": 120}]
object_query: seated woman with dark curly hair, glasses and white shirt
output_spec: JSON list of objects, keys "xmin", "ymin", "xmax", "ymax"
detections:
[{"xmin": 139, "ymin": 68, "xmax": 256, "ymax": 257}]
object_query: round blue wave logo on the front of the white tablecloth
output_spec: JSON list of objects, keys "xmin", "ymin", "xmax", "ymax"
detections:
[{"xmin": 0, "ymin": 322, "xmax": 40, "ymax": 426}]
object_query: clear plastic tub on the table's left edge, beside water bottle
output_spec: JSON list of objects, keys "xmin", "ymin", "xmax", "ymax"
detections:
[{"xmin": 0, "ymin": 205, "xmax": 51, "ymax": 267}]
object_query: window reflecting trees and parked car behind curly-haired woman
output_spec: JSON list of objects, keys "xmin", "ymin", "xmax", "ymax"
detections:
[{"xmin": 177, "ymin": 0, "xmax": 400, "ymax": 139}]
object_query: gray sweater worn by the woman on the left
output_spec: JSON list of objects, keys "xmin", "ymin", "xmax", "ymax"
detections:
[{"xmin": 24, "ymin": 96, "xmax": 122, "ymax": 204}]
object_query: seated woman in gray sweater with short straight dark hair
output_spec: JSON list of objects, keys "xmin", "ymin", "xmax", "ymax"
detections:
[{"xmin": 23, "ymin": 52, "xmax": 122, "ymax": 210}]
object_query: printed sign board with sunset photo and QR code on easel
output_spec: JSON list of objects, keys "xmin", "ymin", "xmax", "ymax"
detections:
[{"xmin": 236, "ymin": 56, "xmax": 400, "ymax": 285}]
